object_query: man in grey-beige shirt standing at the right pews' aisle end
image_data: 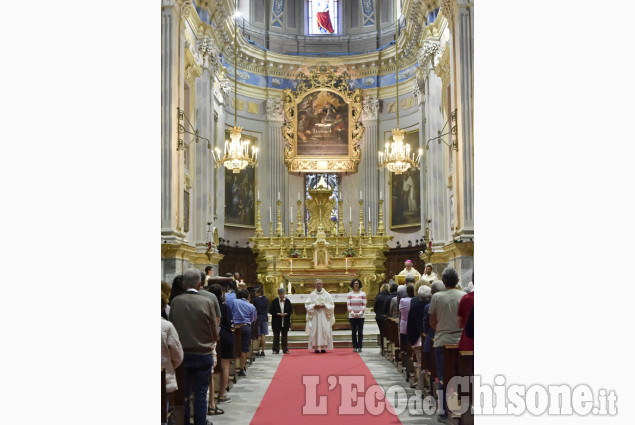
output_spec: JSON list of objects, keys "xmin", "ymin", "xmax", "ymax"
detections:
[{"xmin": 428, "ymin": 267, "xmax": 465, "ymax": 415}]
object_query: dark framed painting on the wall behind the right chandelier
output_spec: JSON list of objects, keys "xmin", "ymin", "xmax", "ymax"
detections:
[{"xmin": 384, "ymin": 129, "xmax": 421, "ymax": 229}]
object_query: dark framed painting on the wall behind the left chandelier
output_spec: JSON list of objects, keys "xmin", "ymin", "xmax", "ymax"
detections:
[{"xmin": 225, "ymin": 130, "xmax": 258, "ymax": 228}]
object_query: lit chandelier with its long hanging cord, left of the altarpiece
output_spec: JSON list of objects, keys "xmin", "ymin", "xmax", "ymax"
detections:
[{"xmin": 212, "ymin": 0, "xmax": 258, "ymax": 173}]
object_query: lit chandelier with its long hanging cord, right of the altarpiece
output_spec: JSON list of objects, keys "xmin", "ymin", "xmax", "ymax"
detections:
[{"xmin": 378, "ymin": 1, "xmax": 423, "ymax": 174}]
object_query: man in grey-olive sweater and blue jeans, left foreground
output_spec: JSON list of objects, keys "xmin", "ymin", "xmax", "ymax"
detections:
[{"xmin": 170, "ymin": 269, "xmax": 218, "ymax": 425}]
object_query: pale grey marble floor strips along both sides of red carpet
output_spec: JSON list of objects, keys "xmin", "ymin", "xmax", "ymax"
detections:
[{"xmin": 207, "ymin": 347, "xmax": 439, "ymax": 425}]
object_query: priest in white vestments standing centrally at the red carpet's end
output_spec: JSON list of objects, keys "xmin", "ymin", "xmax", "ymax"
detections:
[{"xmin": 304, "ymin": 279, "xmax": 335, "ymax": 353}]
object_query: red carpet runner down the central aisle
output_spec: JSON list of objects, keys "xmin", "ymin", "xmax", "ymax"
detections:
[{"xmin": 251, "ymin": 348, "xmax": 401, "ymax": 425}]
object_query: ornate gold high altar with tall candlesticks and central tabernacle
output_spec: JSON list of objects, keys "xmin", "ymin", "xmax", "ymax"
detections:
[{"xmin": 249, "ymin": 181, "xmax": 392, "ymax": 327}]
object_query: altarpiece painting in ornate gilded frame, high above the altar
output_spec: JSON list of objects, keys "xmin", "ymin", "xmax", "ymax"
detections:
[{"xmin": 282, "ymin": 65, "xmax": 364, "ymax": 173}]
